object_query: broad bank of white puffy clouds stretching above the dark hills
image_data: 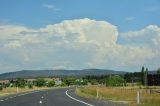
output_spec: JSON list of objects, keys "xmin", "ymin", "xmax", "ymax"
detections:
[{"xmin": 0, "ymin": 18, "xmax": 160, "ymax": 71}]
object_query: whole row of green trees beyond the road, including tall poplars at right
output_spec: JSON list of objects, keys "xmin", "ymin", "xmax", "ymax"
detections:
[{"xmin": 0, "ymin": 67, "xmax": 160, "ymax": 90}]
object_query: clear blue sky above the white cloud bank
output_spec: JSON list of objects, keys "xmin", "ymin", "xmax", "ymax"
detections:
[{"xmin": 0, "ymin": 0, "xmax": 160, "ymax": 31}]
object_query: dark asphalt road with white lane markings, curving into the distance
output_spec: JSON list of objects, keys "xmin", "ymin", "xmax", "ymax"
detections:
[{"xmin": 0, "ymin": 88, "xmax": 127, "ymax": 106}]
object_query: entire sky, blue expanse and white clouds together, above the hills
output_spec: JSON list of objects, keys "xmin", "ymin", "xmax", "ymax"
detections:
[{"xmin": 0, "ymin": 0, "xmax": 160, "ymax": 73}]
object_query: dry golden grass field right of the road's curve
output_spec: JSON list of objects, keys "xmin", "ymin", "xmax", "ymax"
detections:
[{"xmin": 76, "ymin": 86, "xmax": 160, "ymax": 106}]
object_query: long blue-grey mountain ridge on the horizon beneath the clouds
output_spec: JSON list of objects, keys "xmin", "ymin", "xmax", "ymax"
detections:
[{"xmin": 0, "ymin": 69, "xmax": 126, "ymax": 80}]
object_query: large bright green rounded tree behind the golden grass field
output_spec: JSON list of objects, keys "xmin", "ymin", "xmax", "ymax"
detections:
[{"xmin": 106, "ymin": 75, "xmax": 125, "ymax": 86}]
